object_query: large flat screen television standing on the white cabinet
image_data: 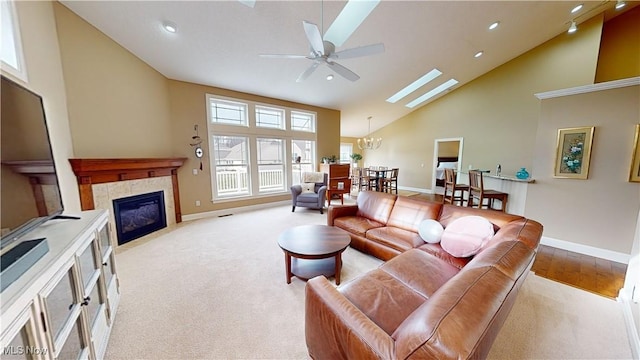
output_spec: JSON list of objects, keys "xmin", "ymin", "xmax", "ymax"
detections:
[{"xmin": 0, "ymin": 76, "xmax": 64, "ymax": 249}]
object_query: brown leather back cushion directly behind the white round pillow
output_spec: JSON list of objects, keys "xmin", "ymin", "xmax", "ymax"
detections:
[{"xmin": 387, "ymin": 196, "xmax": 442, "ymax": 233}]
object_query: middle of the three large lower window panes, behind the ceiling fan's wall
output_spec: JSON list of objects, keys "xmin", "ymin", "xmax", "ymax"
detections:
[{"xmin": 256, "ymin": 138, "xmax": 285, "ymax": 192}]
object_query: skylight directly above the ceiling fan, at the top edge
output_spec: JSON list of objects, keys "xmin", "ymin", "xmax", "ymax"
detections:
[{"xmin": 324, "ymin": 0, "xmax": 380, "ymax": 47}]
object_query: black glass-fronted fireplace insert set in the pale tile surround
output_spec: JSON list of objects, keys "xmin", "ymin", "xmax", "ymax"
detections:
[{"xmin": 113, "ymin": 191, "xmax": 167, "ymax": 245}]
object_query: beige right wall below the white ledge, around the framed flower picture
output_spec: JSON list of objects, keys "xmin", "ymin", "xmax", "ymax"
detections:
[{"xmin": 525, "ymin": 85, "xmax": 640, "ymax": 254}]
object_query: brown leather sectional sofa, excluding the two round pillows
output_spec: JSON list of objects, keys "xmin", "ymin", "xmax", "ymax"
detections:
[{"xmin": 305, "ymin": 192, "xmax": 542, "ymax": 360}]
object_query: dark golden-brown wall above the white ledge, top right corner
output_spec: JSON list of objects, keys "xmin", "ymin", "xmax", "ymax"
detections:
[{"xmin": 596, "ymin": 6, "xmax": 640, "ymax": 83}]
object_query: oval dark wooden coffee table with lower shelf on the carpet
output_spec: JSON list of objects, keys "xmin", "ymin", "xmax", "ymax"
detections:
[{"xmin": 278, "ymin": 225, "xmax": 351, "ymax": 285}]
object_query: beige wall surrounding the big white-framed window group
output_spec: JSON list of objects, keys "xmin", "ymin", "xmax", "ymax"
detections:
[{"xmin": 169, "ymin": 80, "xmax": 340, "ymax": 215}]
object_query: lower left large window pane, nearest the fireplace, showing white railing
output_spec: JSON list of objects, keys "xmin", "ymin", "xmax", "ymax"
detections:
[{"xmin": 212, "ymin": 135, "xmax": 250, "ymax": 197}]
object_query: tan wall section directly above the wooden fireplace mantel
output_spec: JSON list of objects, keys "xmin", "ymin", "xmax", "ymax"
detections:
[{"xmin": 53, "ymin": 2, "xmax": 174, "ymax": 158}]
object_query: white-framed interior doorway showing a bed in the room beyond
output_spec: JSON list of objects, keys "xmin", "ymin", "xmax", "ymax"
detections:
[{"xmin": 431, "ymin": 137, "xmax": 464, "ymax": 194}]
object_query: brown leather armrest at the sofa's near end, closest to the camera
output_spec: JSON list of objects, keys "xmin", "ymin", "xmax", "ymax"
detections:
[{"xmin": 305, "ymin": 276, "xmax": 394, "ymax": 360}]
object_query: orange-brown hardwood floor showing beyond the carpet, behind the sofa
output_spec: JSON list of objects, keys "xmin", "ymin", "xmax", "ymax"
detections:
[{"xmin": 404, "ymin": 194, "xmax": 627, "ymax": 299}]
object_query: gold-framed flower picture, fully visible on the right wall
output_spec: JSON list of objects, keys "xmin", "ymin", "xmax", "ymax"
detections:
[{"xmin": 553, "ymin": 126, "xmax": 595, "ymax": 180}]
